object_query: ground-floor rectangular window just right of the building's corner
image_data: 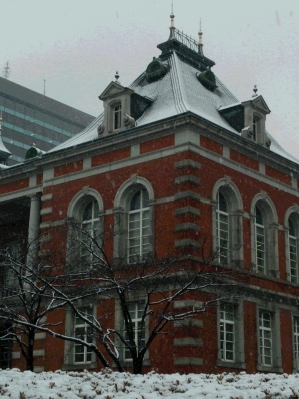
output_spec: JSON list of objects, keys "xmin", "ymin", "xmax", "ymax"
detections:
[{"xmin": 220, "ymin": 304, "xmax": 236, "ymax": 362}]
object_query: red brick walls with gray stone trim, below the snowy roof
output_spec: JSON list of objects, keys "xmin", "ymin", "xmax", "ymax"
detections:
[{"xmin": 0, "ymin": 28, "xmax": 299, "ymax": 373}]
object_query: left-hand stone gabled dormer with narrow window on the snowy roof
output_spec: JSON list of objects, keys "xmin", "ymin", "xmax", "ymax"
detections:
[{"xmin": 98, "ymin": 75, "xmax": 135, "ymax": 136}]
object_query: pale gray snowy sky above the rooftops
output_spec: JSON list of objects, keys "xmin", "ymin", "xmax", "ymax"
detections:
[{"xmin": 0, "ymin": 0, "xmax": 299, "ymax": 158}]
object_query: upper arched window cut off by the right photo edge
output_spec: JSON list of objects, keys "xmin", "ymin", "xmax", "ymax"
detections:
[{"xmin": 288, "ymin": 213, "xmax": 299, "ymax": 284}]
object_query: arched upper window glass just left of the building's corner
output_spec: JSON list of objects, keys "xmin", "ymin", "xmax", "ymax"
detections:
[{"xmin": 128, "ymin": 189, "xmax": 150, "ymax": 263}]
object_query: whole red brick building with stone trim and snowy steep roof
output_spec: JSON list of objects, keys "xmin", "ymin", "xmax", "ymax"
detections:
[{"xmin": 0, "ymin": 24, "xmax": 299, "ymax": 373}]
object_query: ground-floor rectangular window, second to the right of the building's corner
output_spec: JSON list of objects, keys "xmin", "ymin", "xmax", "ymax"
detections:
[{"xmin": 259, "ymin": 311, "xmax": 273, "ymax": 366}]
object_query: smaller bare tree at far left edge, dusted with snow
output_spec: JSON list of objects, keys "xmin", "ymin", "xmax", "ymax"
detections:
[{"xmin": 0, "ymin": 236, "xmax": 106, "ymax": 371}]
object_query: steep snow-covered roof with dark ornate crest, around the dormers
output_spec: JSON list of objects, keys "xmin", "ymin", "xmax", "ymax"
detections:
[{"xmin": 49, "ymin": 29, "xmax": 299, "ymax": 163}]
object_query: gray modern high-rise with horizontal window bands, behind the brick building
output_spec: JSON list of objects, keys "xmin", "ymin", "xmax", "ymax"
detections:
[{"xmin": 0, "ymin": 77, "xmax": 94, "ymax": 165}]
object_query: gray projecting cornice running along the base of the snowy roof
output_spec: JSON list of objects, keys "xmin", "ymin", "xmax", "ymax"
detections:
[{"xmin": 0, "ymin": 112, "xmax": 299, "ymax": 184}]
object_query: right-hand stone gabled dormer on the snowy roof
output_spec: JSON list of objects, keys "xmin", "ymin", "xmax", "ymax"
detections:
[{"xmin": 241, "ymin": 86, "xmax": 271, "ymax": 148}]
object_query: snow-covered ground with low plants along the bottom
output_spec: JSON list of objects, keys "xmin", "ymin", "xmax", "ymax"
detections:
[{"xmin": 0, "ymin": 369, "xmax": 299, "ymax": 399}]
